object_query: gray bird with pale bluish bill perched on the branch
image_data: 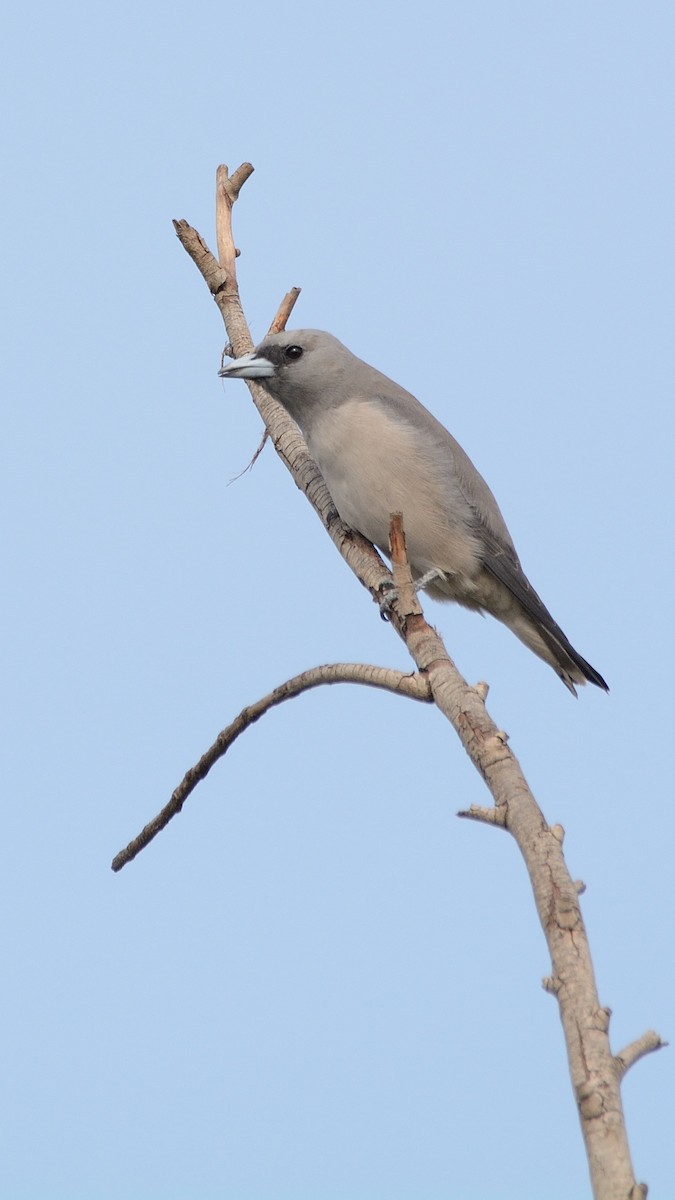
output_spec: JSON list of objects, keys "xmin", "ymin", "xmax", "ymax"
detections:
[{"xmin": 220, "ymin": 329, "xmax": 609, "ymax": 695}]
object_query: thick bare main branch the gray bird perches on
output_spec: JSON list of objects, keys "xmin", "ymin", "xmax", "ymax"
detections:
[{"xmin": 163, "ymin": 169, "xmax": 658, "ymax": 1200}]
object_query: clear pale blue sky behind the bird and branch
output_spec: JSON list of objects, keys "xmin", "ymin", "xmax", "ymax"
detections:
[{"xmin": 0, "ymin": 0, "xmax": 675, "ymax": 1200}]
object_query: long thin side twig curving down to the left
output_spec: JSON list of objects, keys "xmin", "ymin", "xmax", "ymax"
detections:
[{"xmin": 112, "ymin": 662, "xmax": 431, "ymax": 871}]
